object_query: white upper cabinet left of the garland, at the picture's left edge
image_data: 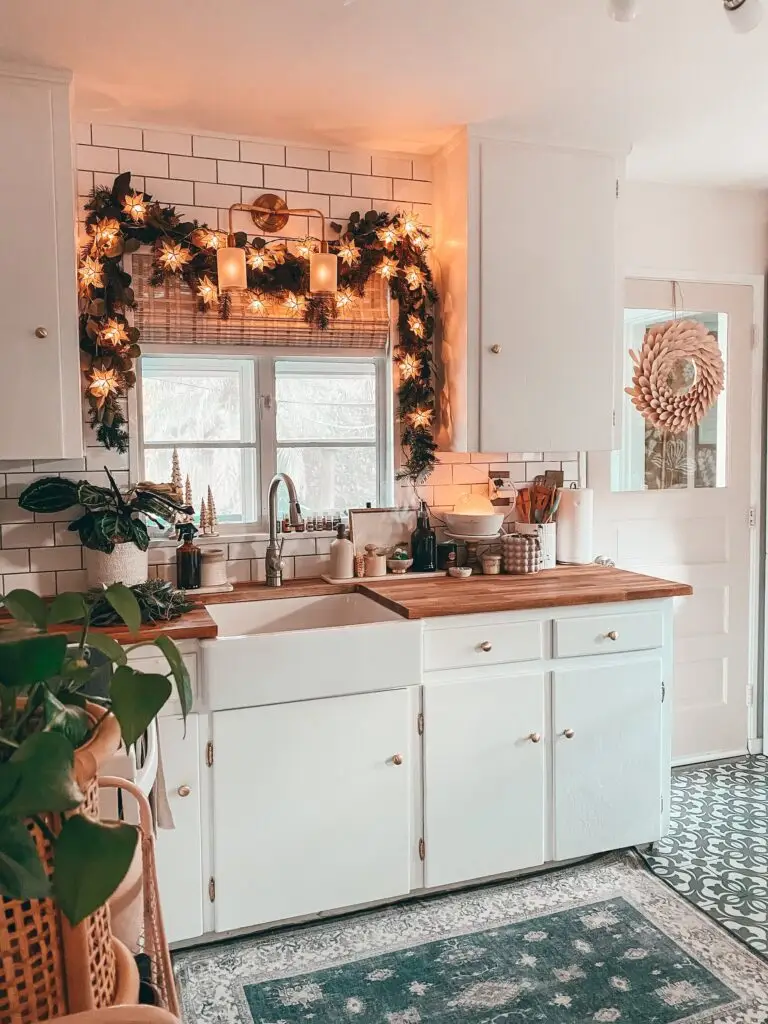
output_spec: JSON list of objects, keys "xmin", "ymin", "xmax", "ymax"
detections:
[{"xmin": 0, "ymin": 63, "xmax": 83, "ymax": 459}]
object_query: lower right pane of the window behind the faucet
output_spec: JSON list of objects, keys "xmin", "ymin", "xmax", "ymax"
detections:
[{"xmin": 278, "ymin": 445, "xmax": 378, "ymax": 515}]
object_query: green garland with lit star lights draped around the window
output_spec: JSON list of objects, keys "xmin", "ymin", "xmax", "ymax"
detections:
[{"xmin": 78, "ymin": 172, "xmax": 437, "ymax": 483}]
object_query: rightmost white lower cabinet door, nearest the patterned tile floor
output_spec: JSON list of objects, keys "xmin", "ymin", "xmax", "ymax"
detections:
[{"xmin": 553, "ymin": 655, "xmax": 664, "ymax": 860}]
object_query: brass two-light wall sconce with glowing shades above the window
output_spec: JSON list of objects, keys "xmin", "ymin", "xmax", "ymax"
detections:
[{"xmin": 216, "ymin": 193, "xmax": 339, "ymax": 295}]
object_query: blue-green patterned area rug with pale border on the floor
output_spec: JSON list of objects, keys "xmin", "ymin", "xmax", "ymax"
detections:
[{"xmin": 175, "ymin": 854, "xmax": 768, "ymax": 1024}]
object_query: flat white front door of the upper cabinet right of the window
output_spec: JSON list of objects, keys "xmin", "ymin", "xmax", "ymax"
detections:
[{"xmin": 477, "ymin": 139, "xmax": 617, "ymax": 452}]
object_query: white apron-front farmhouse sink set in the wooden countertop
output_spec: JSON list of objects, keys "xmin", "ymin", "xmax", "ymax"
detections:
[{"xmin": 201, "ymin": 594, "xmax": 422, "ymax": 711}]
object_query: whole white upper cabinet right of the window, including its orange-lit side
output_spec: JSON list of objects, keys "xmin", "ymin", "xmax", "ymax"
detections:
[{"xmin": 434, "ymin": 128, "xmax": 620, "ymax": 452}]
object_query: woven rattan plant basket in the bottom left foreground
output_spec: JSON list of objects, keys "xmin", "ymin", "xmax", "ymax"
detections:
[{"xmin": 0, "ymin": 705, "xmax": 138, "ymax": 1024}]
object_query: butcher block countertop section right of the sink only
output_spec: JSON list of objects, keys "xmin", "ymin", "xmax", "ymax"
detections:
[{"xmin": 358, "ymin": 565, "xmax": 693, "ymax": 618}]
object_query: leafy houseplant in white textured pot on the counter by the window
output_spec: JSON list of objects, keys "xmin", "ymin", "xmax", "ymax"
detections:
[{"xmin": 18, "ymin": 467, "xmax": 195, "ymax": 587}]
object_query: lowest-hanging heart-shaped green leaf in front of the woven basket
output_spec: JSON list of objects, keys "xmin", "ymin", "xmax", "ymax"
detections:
[{"xmin": 53, "ymin": 814, "xmax": 138, "ymax": 925}]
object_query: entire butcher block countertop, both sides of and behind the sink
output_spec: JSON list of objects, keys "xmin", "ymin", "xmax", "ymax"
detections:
[{"xmin": 6, "ymin": 565, "xmax": 693, "ymax": 644}]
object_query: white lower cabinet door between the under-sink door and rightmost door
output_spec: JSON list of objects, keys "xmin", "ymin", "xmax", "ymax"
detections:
[{"xmin": 424, "ymin": 674, "xmax": 548, "ymax": 887}]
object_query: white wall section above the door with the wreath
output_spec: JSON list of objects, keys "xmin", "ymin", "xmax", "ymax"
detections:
[{"xmin": 620, "ymin": 181, "xmax": 768, "ymax": 279}]
